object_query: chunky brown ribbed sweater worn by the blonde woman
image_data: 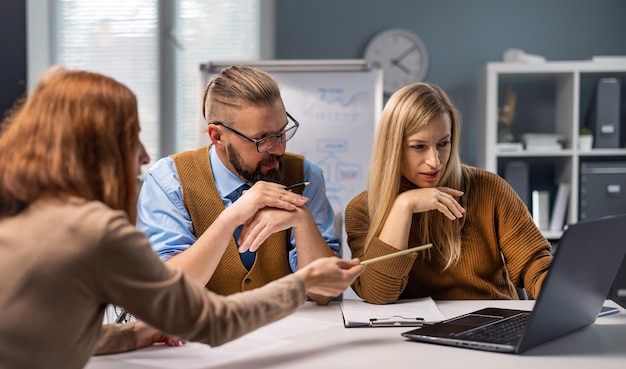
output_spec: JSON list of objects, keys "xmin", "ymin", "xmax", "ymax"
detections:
[{"xmin": 345, "ymin": 168, "xmax": 552, "ymax": 304}]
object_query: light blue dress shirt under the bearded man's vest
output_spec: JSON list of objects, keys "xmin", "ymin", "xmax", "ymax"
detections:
[{"xmin": 137, "ymin": 147, "xmax": 340, "ymax": 271}]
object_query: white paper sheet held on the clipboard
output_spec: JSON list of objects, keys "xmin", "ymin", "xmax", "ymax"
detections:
[{"xmin": 341, "ymin": 297, "xmax": 445, "ymax": 328}]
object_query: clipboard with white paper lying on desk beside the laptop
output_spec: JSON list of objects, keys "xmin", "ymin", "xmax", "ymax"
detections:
[{"xmin": 341, "ymin": 297, "xmax": 445, "ymax": 328}]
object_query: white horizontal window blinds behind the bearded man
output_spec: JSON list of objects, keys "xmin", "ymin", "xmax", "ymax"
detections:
[{"xmin": 53, "ymin": 0, "xmax": 260, "ymax": 161}]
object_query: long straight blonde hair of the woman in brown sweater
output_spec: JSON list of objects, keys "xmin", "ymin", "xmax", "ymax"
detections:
[{"xmin": 365, "ymin": 83, "xmax": 467, "ymax": 269}]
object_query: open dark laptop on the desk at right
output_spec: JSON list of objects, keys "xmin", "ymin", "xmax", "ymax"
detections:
[{"xmin": 402, "ymin": 215, "xmax": 626, "ymax": 353}]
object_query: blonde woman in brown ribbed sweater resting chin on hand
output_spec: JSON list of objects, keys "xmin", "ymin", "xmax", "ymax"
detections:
[{"xmin": 345, "ymin": 83, "xmax": 552, "ymax": 304}]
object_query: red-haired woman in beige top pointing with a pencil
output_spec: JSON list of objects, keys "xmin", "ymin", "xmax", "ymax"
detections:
[{"xmin": 0, "ymin": 67, "xmax": 363, "ymax": 368}]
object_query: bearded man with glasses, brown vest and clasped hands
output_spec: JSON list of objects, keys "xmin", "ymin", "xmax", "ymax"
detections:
[{"xmin": 137, "ymin": 66, "xmax": 340, "ymax": 305}]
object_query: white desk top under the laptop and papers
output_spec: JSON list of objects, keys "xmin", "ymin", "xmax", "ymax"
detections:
[{"xmin": 86, "ymin": 301, "xmax": 626, "ymax": 369}]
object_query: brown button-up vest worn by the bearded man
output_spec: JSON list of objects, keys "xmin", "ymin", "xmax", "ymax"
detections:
[{"xmin": 171, "ymin": 145, "xmax": 304, "ymax": 295}]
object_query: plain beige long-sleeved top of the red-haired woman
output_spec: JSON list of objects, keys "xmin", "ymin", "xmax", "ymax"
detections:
[{"xmin": 0, "ymin": 199, "xmax": 305, "ymax": 369}]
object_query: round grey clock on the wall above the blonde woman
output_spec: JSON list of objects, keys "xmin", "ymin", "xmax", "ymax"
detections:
[{"xmin": 365, "ymin": 29, "xmax": 428, "ymax": 94}]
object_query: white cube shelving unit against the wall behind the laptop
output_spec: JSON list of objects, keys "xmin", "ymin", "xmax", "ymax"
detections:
[{"xmin": 476, "ymin": 58, "xmax": 626, "ymax": 239}]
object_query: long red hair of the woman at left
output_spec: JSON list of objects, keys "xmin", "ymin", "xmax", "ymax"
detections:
[{"xmin": 0, "ymin": 67, "xmax": 139, "ymax": 222}]
